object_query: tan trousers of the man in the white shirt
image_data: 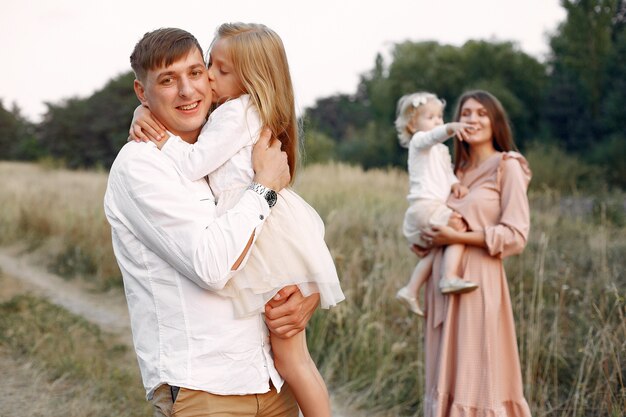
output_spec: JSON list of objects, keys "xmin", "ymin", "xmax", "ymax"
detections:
[{"xmin": 151, "ymin": 384, "xmax": 298, "ymax": 417}]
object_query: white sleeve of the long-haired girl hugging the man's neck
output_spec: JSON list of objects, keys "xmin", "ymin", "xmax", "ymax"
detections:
[{"xmin": 161, "ymin": 98, "xmax": 261, "ymax": 181}]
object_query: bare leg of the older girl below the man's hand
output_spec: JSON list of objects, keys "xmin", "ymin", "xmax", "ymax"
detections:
[{"xmin": 270, "ymin": 331, "xmax": 331, "ymax": 417}]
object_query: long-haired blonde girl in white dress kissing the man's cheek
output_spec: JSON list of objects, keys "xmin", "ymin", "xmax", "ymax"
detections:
[{"xmin": 131, "ymin": 23, "xmax": 344, "ymax": 417}]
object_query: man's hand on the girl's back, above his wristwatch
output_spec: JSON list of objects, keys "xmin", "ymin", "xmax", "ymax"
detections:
[{"xmin": 252, "ymin": 128, "xmax": 291, "ymax": 191}]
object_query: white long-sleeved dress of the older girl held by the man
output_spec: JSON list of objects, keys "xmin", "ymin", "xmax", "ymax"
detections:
[{"xmin": 162, "ymin": 95, "xmax": 345, "ymax": 317}]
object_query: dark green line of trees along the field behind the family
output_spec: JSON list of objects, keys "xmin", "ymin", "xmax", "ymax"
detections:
[{"xmin": 0, "ymin": 0, "xmax": 626, "ymax": 188}]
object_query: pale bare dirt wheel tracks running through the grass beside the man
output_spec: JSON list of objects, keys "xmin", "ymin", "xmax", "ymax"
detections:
[{"xmin": 0, "ymin": 246, "xmax": 364, "ymax": 417}]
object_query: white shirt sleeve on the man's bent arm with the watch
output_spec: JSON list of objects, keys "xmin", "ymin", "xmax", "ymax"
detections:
[{"xmin": 105, "ymin": 144, "xmax": 269, "ymax": 290}]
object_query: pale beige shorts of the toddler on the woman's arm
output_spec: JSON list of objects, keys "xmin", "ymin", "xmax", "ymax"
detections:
[{"xmin": 402, "ymin": 199, "xmax": 452, "ymax": 248}]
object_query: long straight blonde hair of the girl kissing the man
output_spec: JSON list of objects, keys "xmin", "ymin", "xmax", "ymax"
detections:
[{"xmin": 211, "ymin": 23, "xmax": 298, "ymax": 182}]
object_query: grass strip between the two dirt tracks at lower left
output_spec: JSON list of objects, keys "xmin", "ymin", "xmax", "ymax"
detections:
[{"xmin": 0, "ymin": 290, "xmax": 152, "ymax": 417}]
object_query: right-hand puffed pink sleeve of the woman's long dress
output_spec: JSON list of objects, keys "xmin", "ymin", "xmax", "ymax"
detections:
[{"xmin": 485, "ymin": 152, "xmax": 531, "ymax": 258}]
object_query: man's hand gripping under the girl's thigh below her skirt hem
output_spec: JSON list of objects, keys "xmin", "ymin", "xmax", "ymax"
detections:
[{"xmin": 265, "ymin": 285, "xmax": 320, "ymax": 339}]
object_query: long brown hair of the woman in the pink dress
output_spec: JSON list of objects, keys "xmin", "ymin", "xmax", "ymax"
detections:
[{"xmin": 454, "ymin": 90, "xmax": 517, "ymax": 172}]
